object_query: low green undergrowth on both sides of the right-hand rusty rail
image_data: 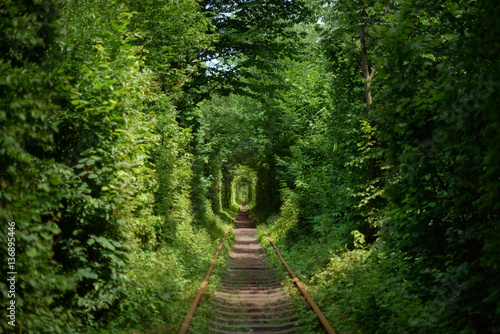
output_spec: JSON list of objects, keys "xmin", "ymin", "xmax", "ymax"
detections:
[{"xmin": 254, "ymin": 192, "xmax": 476, "ymax": 334}]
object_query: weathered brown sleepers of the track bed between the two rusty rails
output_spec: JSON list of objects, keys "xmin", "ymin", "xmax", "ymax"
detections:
[{"xmin": 210, "ymin": 205, "xmax": 298, "ymax": 334}]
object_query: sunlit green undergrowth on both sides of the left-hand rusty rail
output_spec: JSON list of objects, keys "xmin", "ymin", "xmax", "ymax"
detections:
[{"xmin": 97, "ymin": 207, "xmax": 235, "ymax": 334}]
